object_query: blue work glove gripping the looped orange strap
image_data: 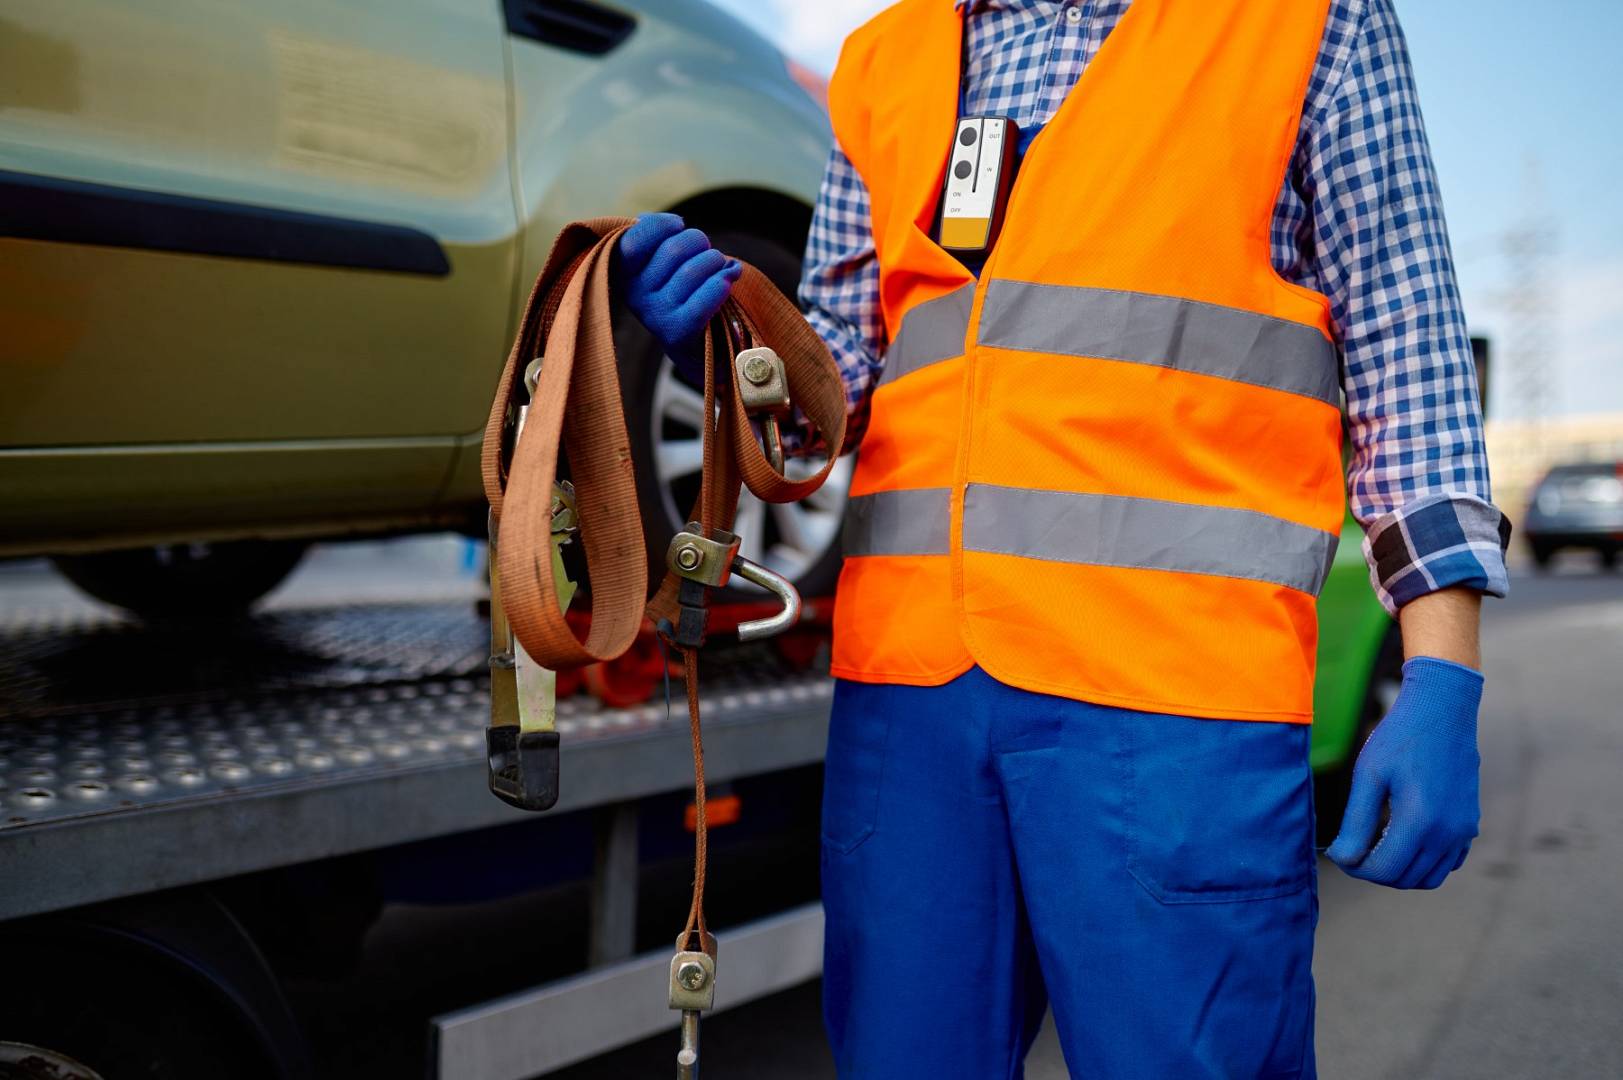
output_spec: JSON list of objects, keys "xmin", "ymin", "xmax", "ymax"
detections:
[{"xmin": 617, "ymin": 214, "xmax": 743, "ymax": 387}]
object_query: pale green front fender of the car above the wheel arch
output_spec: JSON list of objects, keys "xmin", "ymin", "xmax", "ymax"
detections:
[{"xmin": 441, "ymin": 0, "xmax": 833, "ymax": 513}]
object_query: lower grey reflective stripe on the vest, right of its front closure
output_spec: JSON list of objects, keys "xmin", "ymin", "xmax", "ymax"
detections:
[{"xmin": 964, "ymin": 484, "xmax": 1339, "ymax": 596}]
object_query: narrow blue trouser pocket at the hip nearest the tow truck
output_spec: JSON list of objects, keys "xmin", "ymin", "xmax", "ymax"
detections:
[{"xmin": 823, "ymin": 680, "xmax": 891, "ymax": 854}]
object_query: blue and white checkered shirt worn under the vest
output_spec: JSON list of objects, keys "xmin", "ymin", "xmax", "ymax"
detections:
[{"xmin": 800, "ymin": 0, "xmax": 1509, "ymax": 612}]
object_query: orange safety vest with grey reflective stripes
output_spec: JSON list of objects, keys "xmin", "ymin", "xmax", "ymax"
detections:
[{"xmin": 829, "ymin": 0, "xmax": 1345, "ymax": 723}]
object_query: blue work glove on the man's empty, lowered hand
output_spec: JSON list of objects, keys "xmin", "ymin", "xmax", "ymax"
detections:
[{"xmin": 1324, "ymin": 656, "xmax": 1482, "ymax": 888}]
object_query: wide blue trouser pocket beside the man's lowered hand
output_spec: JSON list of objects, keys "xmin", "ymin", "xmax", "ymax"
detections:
[{"xmin": 1117, "ymin": 715, "xmax": 1313, "ymax": 903}]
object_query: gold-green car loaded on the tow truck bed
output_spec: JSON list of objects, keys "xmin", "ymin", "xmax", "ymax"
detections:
[{"xmin": 0, "ymin": 0, "xmax": 844, "ymax": 614}]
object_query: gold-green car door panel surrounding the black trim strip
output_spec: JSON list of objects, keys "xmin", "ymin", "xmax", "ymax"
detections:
[{"xmin": 0, "ymin": 0, "xmax": 518, "ymax": 461}]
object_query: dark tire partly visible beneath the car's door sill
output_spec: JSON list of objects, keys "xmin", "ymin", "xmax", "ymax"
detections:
[{"xmin": 54, "ymin": 541, "xmax": 307, "ymax": 620}]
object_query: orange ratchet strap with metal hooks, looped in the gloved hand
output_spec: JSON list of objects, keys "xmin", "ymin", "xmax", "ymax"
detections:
[{"xmin": 482, "ymin": 218, "xmax": 846, "ymax": 1074}]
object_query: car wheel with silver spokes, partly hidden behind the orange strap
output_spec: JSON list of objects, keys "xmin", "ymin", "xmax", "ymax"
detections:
[{"xmin": 615, "ymin": 229, "xmax": 854, "ymax": 601}]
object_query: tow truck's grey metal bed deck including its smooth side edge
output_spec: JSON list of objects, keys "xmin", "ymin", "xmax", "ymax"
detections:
[{"xmin": 0, "ymin": 603, "xmax": 831, "ymax": 918}]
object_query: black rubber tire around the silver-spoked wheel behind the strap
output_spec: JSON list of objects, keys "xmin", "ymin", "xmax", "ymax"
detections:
[{"xmin": 610, "ymin": 222, "xmax": 844, "ymax": 601}]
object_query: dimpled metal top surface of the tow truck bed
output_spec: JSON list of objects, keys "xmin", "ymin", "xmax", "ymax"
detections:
[{"xmin": 0, "ymin": 604, "xmax": 831, "ymax": 832}]
